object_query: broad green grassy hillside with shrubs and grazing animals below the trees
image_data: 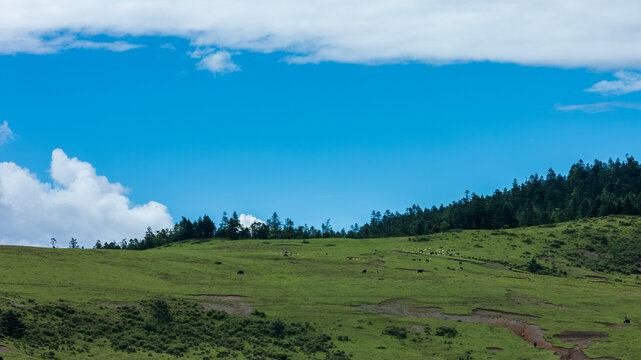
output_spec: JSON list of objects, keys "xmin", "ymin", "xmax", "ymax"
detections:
[{"xmin": 0, "ymin": 216, "xmax": 641, "ymax": 359}]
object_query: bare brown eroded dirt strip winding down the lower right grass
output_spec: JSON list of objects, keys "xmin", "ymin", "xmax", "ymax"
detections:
[{"xmin": 358, "ymin": 299, "xmax": 617, "ymax": 360}]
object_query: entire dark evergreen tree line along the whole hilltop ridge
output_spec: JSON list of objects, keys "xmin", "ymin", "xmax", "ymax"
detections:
[{"xmin": 95, "ymin": 157, "xmax": 641, "ymax": 250}]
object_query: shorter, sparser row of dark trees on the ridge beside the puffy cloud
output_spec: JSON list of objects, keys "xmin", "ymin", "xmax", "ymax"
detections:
[{"xmin": 94, "ymin": 212, "xmax": 348, "ymax": 250}]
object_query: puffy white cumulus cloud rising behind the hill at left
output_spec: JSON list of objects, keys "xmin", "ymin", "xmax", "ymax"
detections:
[{"xmin": 0, "ymin": 149, "xmax": 172, "ymax": 246}]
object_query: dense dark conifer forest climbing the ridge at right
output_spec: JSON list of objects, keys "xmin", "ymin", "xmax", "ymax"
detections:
[{"xmin": 350, "ymin": 157, "xmax": 641, "ymax": 238}]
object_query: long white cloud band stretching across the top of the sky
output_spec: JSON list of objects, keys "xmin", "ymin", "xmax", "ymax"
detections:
[{"xmin": 0, "ymin": 0, "xmax": 641, "ymax": 68}]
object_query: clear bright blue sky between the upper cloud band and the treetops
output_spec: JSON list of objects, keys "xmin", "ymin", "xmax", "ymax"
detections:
[{"xmin": 0, "ymin": 0, "xmax": 641, "ymax": 242}]
